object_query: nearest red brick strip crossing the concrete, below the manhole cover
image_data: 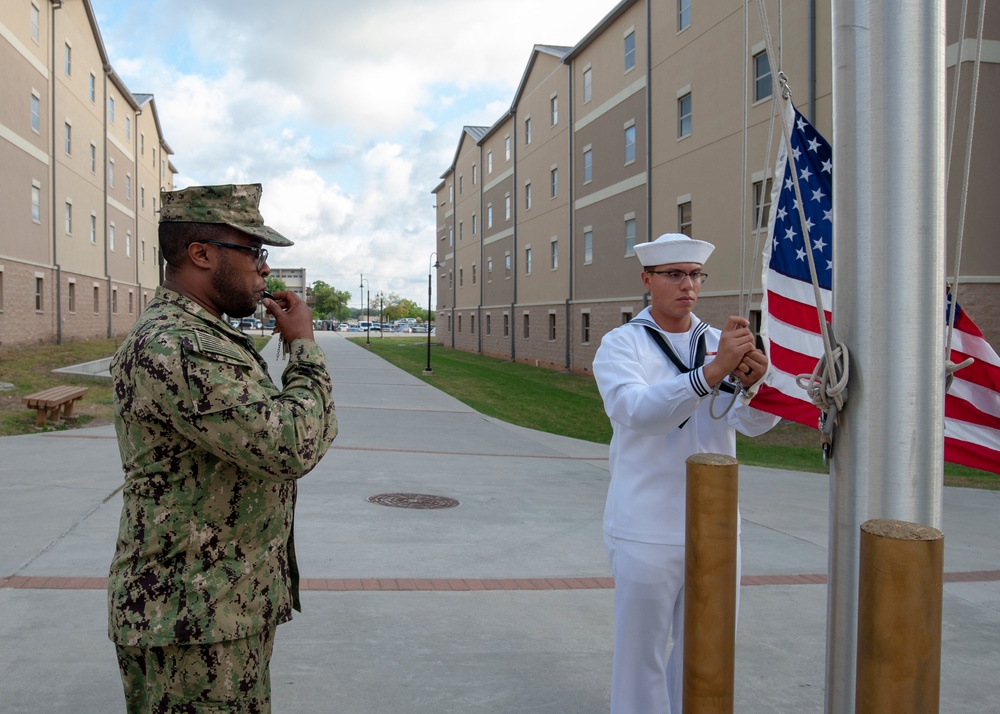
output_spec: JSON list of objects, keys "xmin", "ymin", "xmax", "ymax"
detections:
[{"xmin": 0, "ymin": 570, "xmax": 1000, "ymax": 592}]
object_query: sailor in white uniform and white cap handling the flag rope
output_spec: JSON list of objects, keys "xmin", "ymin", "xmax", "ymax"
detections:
[{"xmin": 594, "ymin": 233, "xmax": 779, "ymax": 714}]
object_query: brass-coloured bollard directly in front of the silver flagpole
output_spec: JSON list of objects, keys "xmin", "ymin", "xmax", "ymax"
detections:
[{"xmin": 854, "ymin": 519, "xmax": 944, "ymax": 714}]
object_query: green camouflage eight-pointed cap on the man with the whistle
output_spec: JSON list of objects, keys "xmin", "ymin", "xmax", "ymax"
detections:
[{"xmin": 160, "ymin": 183, "xmax": 293, "ymax": 246}]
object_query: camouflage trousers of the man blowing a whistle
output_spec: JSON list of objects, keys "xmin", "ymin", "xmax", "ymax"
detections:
[{"xmin": 116, "ymin": 628, "xmax": 274, "ymax": 714}]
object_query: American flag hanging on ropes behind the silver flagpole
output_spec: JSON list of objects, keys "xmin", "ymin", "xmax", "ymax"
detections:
[{"xmin": 753, "ymin": 103, "xmax": 1000, "ymax": 473}]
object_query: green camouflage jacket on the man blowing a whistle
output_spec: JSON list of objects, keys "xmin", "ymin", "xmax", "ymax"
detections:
[{"xmin": 108, "ymin": 287, "xmax": 337, "ymax": 647}]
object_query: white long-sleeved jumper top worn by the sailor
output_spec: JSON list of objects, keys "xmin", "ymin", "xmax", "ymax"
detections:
[{"xmin": 594, "ymin": 307, "xmax": 780, "ymax": 545}]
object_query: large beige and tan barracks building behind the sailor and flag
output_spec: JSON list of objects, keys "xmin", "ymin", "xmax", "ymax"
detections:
[{"xmin": 433, "ymin": 0, "xmax": 1000, "ymax": 373}]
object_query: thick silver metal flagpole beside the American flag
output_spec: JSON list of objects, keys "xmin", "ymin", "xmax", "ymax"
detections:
[{"xmin": 826, "ymin": 0, "xmax": 946, "ymax": 714}]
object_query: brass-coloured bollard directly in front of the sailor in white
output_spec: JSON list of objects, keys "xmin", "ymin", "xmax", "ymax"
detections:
[{"xmin": 683, "ymin": 454, "xmax": 739, "ymax": 714}]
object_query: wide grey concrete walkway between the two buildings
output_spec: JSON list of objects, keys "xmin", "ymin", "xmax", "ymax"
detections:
[{"xmin": 0, "ymin": 332, "xmax": 1000, "ymax": 714}]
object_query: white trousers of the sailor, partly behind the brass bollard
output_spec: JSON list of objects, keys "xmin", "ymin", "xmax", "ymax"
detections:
[{"xmin": 604, "ymin": 534, "xmax": 741, "ymax": 714}]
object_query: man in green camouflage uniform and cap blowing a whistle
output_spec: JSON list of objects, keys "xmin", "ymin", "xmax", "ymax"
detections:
[{"xmin": 108, "ymin": 184, "xmax": 337, "ymax": 714}]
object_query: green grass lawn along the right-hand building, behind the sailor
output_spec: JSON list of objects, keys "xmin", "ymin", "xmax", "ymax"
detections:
[{"xmin": 350, "ymin": 337, "xmax": 1000, "ymax": 490}]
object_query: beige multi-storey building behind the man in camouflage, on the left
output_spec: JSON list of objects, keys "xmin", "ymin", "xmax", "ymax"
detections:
[{"xmin": 0, "ymin": 0, "xmax": 175, "ymax": 347}]
